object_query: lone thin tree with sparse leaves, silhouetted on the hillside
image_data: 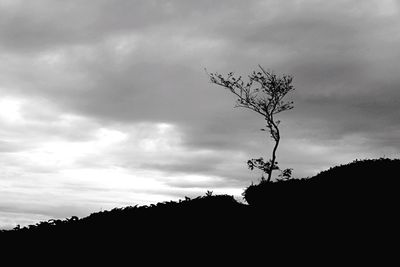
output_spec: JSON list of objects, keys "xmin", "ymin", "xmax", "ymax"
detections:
[{"xmin": 207, "ymin": 65, "xmax": 294, "ymax": 182}]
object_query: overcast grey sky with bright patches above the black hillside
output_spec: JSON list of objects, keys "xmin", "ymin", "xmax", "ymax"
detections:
[{"xmin": 0, "ymin": 0, "xmax": 400, "ymax": 229}]
